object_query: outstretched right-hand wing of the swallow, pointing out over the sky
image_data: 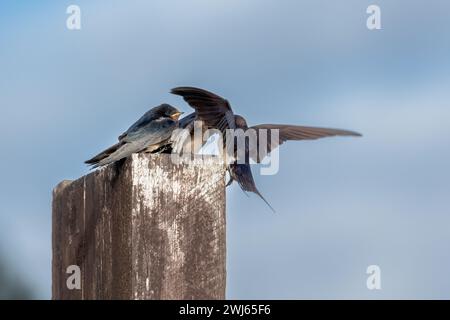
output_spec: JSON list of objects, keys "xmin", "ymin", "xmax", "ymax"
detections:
[{"xmin": 250, "ymin": 124, "xmax": 361, "ymax": 162}]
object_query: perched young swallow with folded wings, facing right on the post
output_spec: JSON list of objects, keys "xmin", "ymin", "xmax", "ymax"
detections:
[{"xmin": 85, "ymin": 104, "xmax": 182, "ymax": 168}]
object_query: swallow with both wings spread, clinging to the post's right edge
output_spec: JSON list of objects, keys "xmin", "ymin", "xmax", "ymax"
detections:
[{"xmin": 171, "ymin": 87, "xmax": 361, "ymax": 211}]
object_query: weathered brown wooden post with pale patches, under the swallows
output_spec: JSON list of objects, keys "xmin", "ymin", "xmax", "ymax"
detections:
[{"xmin": 52, "ymin": 154, "xmax": 226, "ymax": 299}]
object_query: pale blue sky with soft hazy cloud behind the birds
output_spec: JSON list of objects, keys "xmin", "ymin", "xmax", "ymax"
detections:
[{"xmin": 0, "ymin": 0, "xmax": 450, "ymax": 298}]
